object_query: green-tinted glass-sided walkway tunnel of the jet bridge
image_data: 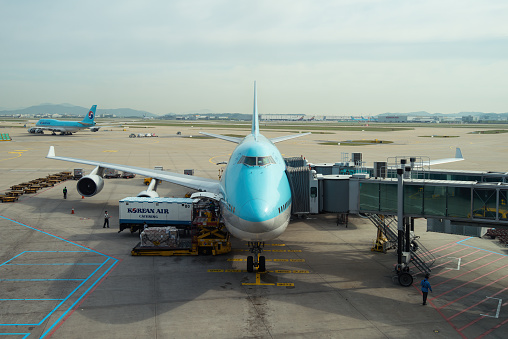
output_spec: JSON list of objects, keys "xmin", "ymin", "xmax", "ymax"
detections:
[{"xmin": 350, "ymin": 179, "xmax": 508, "ymax": 227}]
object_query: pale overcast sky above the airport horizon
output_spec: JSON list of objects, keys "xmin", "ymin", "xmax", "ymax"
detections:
[{"xmin": 0, "ymin": 0, "xmax": 508, "ymax": 115}]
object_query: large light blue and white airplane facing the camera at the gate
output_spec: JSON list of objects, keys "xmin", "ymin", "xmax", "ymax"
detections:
[{"xmin": 47, "ymin": 83, "xmax": 310, "ymax": 272}]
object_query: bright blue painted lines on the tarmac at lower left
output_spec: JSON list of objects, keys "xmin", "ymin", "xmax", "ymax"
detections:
[{"xmin": 0, "ymin": 216, "xmax": 119, "ymax": 338}]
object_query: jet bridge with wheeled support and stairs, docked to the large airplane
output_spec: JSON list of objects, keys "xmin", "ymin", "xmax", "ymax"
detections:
[{"xmin": 302, "ymin": 155, "xmax": 508, "ymax": 286}]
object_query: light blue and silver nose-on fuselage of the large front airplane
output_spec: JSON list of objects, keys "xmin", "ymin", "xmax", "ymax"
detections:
[{"xmin": 220, "ymin": 134, "xmax": 291, "ymax": 241}]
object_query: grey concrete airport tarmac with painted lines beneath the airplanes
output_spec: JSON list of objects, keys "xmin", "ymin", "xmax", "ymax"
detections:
[{"xmin": 0, "ymin": 124, "xmax": 508, "ymax": 339}]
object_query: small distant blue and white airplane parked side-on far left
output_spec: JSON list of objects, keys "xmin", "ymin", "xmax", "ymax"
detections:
[{"xmin": 28, "ymin": 105, "xmax": 100, "ymax": 135}]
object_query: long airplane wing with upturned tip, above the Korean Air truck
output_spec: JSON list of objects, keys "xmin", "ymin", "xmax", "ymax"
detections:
[{"xmin": 46, "ymin": 146, "xmax": 220, "ymax": 194}]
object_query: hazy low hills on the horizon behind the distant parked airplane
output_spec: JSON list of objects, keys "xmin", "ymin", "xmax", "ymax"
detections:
[{"xmin": 0, "ymin": 104, "xmax": 158, "ymax": 118}]
